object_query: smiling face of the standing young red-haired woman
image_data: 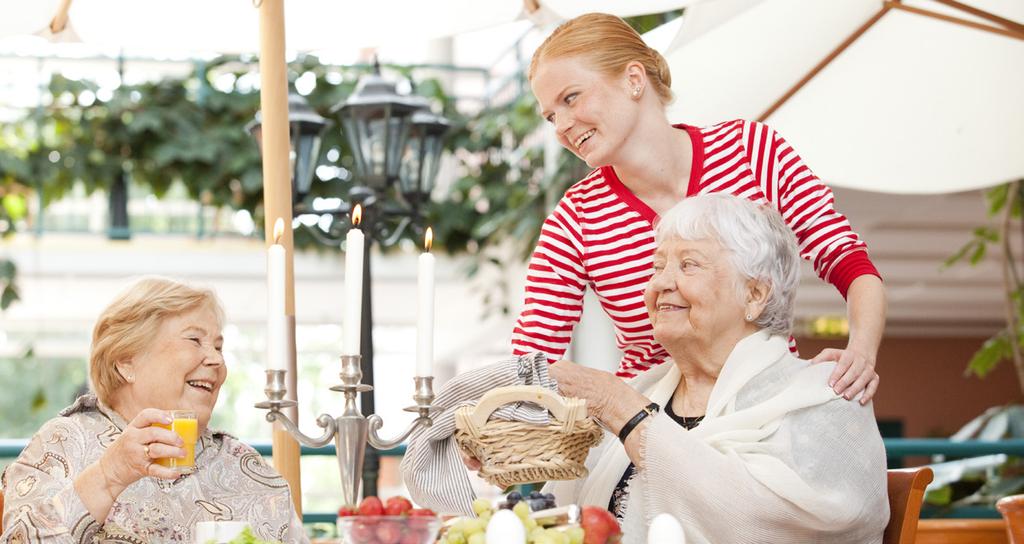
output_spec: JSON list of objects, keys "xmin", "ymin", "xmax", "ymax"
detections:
[{"xmin": 530, "ymin": 56, "xmax": 638, "ymax": 168}]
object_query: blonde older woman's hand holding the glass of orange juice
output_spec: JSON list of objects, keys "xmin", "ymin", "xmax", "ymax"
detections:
[{"xmin": 99, "ymin": 408, "xmax": 185, "ymax": 492}]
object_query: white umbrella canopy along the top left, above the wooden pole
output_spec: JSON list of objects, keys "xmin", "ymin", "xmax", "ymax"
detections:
[{"xmin": 0, "ymin": 0, "xmax": 694, "ymax": 53}]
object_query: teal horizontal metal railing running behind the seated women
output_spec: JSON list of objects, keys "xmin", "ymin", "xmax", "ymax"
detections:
[{"xmin": 0, "ymin": 438, "xmax": 1024, "ymax": 524}]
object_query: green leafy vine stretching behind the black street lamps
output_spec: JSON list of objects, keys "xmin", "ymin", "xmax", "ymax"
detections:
[{"xmin": 0, "ymin": 56, "xmax": 586, "ymax": 310}]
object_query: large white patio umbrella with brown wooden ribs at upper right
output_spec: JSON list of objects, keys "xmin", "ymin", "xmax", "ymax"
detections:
[{"xmin": 666, "ymin": 0, "xmax": 1024, "ymax": 194}]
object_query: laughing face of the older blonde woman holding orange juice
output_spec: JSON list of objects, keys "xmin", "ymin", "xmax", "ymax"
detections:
[{"xmin": 114, "ymin": 306, "xmax": 227, "ymax": 429}]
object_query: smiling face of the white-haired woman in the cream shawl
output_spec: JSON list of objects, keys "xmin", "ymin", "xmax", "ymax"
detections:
[{"xmin": 644, "ymin": 238, "xmax": 757, "ymax": 359}]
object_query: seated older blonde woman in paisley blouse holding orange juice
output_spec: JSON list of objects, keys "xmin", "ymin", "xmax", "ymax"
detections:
[{"xmin": 0, "ymin": 278, "xmax": 307, "ymax": 543}]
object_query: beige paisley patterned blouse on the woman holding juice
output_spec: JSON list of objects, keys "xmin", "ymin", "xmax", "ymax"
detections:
[{"xmin": 0, "ymin": 394, "xmax": 308, "ymax": 544}]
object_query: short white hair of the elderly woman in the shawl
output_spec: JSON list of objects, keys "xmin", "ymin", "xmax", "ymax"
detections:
[{"xmin": 655, "ymin": 193, "xmax": 800, "ymax": 335}]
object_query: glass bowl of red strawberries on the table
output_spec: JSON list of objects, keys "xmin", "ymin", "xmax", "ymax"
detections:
[{"xmin": 338, "ymin": 497, "xmax": 441, "ymax": 544}]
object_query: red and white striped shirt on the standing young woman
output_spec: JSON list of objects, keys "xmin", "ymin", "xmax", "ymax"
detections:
[{"xmin": 512, "ymin": 120, "xmax": 879, "ymax": 377}]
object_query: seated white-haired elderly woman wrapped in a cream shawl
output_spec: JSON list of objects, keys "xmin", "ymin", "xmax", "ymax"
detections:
[{"xmin": 548, "ymin": 195, "xmax": 889, "ymax": 544}]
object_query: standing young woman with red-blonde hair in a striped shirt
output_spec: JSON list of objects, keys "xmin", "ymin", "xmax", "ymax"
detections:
[{"xmin": 512, "ymin": 13, "xmax": 886, "ymax": 403}]
